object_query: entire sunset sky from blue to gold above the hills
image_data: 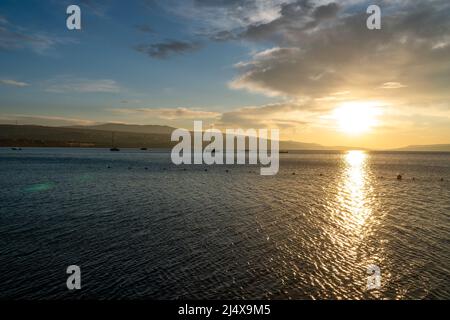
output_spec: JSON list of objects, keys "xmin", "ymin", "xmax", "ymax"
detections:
[{"xmin": 0, "ymin": 0, "xmax": 450, "ymax": 149}]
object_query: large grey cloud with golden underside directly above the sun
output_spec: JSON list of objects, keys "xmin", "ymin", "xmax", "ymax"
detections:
[{"xmin": 230, "ymin": 0, "xmax": 450, "ymax": 104}]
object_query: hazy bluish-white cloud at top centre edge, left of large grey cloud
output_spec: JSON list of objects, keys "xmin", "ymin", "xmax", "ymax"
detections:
[{"xmin": 153, "ymin": 0, "xmax": 340, "ymax": 41}]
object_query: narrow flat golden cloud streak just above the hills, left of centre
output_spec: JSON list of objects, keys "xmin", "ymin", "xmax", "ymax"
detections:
[{"xmin": 111, "ymin": 108, "xmax": 220, "ymax": 120}]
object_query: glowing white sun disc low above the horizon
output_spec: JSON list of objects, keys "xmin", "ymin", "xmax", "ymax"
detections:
[{"xmin": 333, "ymin": 101, "xmax": 381, "ymax": 135}]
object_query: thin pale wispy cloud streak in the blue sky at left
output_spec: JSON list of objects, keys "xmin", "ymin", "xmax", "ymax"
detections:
[{"xmin": 45, "ymin": 77, "xmax": 120, "ymax": 93}]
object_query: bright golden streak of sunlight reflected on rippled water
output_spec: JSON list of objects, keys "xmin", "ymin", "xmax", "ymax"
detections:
[{"xmin": 329, "ymin": 151, "xmax": 383, "ymax": 298}]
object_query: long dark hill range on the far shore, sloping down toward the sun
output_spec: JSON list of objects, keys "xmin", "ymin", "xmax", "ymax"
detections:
[{"xmin": 0, "ymin": 123, "xmax": 361, "ymax": 150}]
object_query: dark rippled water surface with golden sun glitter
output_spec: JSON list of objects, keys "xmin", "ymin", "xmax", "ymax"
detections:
[{"xmin": 0, "ymin": 149, "xmax": 450, "ymax": 299}]
